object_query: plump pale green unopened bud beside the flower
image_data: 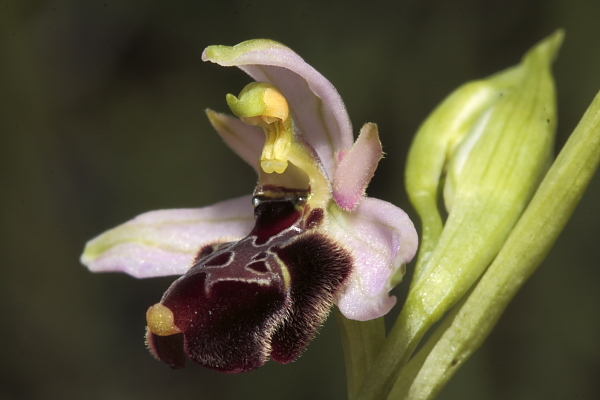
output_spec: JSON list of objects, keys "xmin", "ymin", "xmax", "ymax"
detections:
[{"xmin": 406, "ymin": 31, "xmax": 563, "ymax": 296}]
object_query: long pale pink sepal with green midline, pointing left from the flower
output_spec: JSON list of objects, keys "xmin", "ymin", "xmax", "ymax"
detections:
[{"xmin": 81, "ymin": 196, "xmax": 254, "ymax": 278}]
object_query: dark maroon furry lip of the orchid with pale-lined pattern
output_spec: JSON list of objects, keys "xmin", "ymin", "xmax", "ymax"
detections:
[{"xmin": 147, "ymin": 192, "xmax": 352, "ymax": 373}]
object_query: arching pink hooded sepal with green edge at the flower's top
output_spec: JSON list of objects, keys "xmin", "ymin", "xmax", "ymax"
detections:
[{"xmin": 202, "ymin": 39, "xmax": 353, "ymax": 178}]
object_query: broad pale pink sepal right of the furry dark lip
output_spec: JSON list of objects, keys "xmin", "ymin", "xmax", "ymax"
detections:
[{"xmin": 329, "ymin": 197, "xmax": 418, "ymax": 321}]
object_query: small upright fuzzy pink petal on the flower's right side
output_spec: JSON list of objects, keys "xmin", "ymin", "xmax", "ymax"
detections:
[{"xmin": 333, "ymin": 123, "xmax": 383, "ymax": 211}]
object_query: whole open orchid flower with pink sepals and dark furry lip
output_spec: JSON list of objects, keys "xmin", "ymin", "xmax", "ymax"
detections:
[{"xmin": 81, "ymin": 40, "xmax": 417, "ymax": 373}]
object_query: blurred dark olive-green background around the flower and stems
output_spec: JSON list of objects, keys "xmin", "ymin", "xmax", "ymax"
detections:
[{"xmin": 0, "ymin": 0, "xmax": 600, "ymax": 399}]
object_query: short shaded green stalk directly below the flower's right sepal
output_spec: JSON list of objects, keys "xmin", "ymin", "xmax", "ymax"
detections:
[{"xmin": 335, "ymin": 308, "xmax": 385, "ymax": 400}]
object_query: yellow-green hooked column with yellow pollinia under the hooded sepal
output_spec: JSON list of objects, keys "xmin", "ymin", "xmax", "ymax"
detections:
[{"xmin": 227, "ymin": 82, "xmax": 293, "ymax": 174}]
